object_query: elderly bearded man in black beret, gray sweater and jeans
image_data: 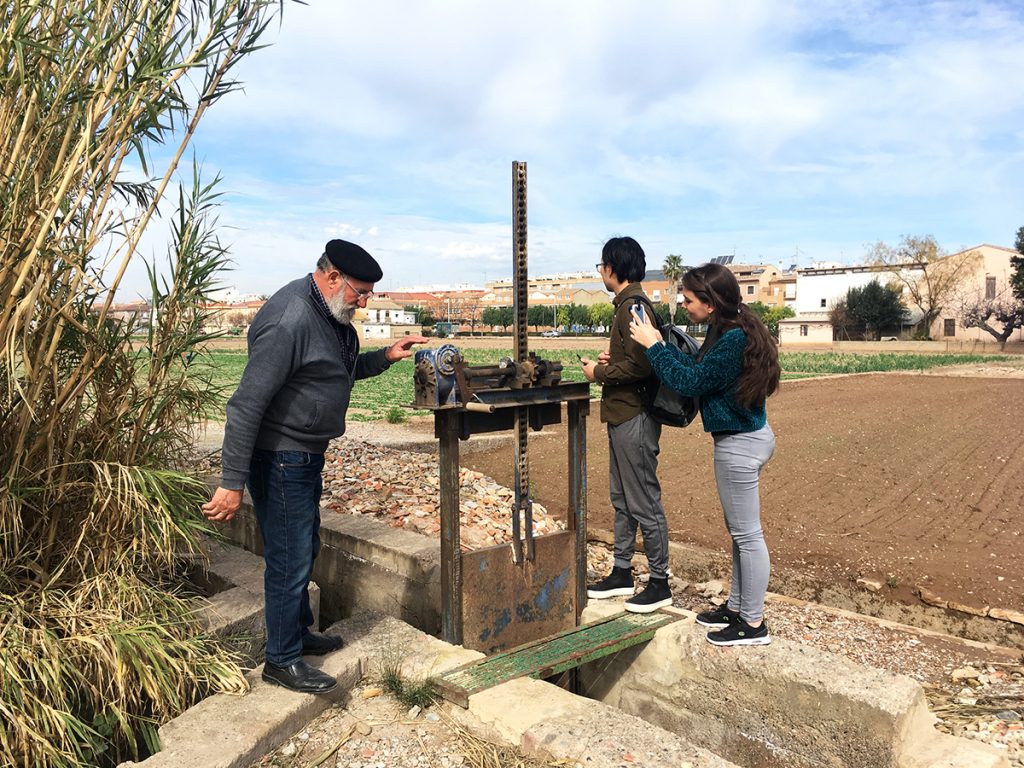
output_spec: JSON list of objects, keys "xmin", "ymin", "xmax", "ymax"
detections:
[{"xmin": 203, "ymin": 240, "xmax": 427, "ymax": 693}]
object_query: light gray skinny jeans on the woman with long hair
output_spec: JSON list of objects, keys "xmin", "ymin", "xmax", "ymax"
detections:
[{"xmin": 715, "ymin": 424, "xmax": 775, "ymax": 623}]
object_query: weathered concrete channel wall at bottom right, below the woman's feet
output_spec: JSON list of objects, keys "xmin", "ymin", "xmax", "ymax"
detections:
[{"xmin": 581, "ymin": 603, "xmax": 1006, "ymax": 768}]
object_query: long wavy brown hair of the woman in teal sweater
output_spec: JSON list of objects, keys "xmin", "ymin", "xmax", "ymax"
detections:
[{"xmin": 683, "ymin": 264, "xmax": 782, "ymax": 409}]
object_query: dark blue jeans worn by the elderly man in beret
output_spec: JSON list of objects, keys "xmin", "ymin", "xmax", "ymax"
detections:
[{"xmin": 248, "ymin": 450, "xmax": 324, "ymax": 667}]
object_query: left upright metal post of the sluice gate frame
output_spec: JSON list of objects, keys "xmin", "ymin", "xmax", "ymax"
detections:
[{"xmin": 434, "ymin": 411, "xmax": 463, "ymax": 645}]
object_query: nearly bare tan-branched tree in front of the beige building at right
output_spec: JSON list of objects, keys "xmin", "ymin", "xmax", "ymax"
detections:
[{"xmin": 867, "ymin": 234, "xmax": 980, "ymax": 338}]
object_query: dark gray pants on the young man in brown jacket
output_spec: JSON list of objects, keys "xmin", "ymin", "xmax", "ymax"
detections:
[{"xmin": 608, "ymin": 411, "xmax": 669, "ymax": 579}]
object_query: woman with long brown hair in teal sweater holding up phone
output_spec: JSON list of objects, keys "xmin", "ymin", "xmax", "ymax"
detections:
[{"xmin": 630, "ymin": 264, "xmax": 780, "ymax": 645}]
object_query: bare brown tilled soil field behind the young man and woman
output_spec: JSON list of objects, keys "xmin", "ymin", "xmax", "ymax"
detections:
[{"xmin": 458, "ymin": 371, "xmax": 1024, "ymax": 610}]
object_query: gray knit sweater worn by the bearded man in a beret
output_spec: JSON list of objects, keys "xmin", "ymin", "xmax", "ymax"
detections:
[{"xmin": 220, "ymin": 274, "xmax": 391, "ymax": 490}]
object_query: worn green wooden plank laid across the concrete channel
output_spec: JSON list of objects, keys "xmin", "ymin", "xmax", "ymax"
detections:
[{"xmin": 439, "ymin": 612, "xmax": 679, "ymax": 706}]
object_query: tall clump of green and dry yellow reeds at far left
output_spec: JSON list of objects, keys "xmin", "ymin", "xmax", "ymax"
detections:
[{"xmin": 0, "ymin": 0, "xmax": 292, "ymax": 767}]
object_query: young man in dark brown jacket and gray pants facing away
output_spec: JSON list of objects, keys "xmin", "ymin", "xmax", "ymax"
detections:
[{"xmin": 580, "ymin": 238, "xmax": 672, "ymax": 613}]
